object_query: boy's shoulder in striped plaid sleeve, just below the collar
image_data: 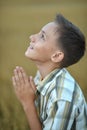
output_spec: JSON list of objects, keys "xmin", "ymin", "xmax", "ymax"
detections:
[{"xmin": 50, "ymin": 69, "xmax": 75, "ymax": 102}]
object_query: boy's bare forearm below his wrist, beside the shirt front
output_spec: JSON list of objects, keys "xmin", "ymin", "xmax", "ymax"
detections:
[{"xmin": 24, "ymin": 102, "xmax": 42, "ymax": 130}]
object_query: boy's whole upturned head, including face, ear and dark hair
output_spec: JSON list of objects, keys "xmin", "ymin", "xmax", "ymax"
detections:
[{"xmin": 25, "ymin": 14, "xmax": 85, "ymax": 68}]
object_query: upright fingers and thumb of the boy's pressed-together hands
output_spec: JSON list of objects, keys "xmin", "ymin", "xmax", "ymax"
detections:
[{"xmin": 12, "ymin": 66, "xmax": 36, "ymax": 94}]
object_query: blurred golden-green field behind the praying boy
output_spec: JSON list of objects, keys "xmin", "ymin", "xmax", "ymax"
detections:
[{"xmin": 0, "ymin": 0, "xmax": 87, "ymax": 130}]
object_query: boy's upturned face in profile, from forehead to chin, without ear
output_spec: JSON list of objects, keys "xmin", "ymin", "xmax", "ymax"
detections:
[{"xmin": 25, "ymin": 22, "xmax": 58, "ymax": 62}]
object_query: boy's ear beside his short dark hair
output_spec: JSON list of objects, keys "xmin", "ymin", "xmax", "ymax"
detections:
[{"xmin": 51, "ymin": 51, "xmax": 64, "ymax": 63}]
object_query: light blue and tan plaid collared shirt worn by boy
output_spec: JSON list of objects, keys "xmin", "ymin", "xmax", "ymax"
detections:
[{"xmin": 35, "ymin": 68, "xmax": 87, "ymax": 130}]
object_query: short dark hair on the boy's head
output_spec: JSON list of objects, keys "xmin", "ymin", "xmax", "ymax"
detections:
[{"xmin": 55, "ymin": 14, "xmax": 86, "ymax": 67}]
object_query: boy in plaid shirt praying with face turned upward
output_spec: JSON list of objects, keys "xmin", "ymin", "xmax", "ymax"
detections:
[{"xmin": 12, "ymin": 14, "xmax": 87, "ymax": 130}]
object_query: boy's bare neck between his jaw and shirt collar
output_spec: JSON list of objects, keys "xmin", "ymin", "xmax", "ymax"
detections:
[{"xmin": 36, "ymin": 63, "xmax": 58, "ymax": 79}]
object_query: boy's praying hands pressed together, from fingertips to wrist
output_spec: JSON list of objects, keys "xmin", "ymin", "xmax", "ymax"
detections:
[{"xmin": 12, "ymin": 66, "xmax": 36, "ymax": 104}]
